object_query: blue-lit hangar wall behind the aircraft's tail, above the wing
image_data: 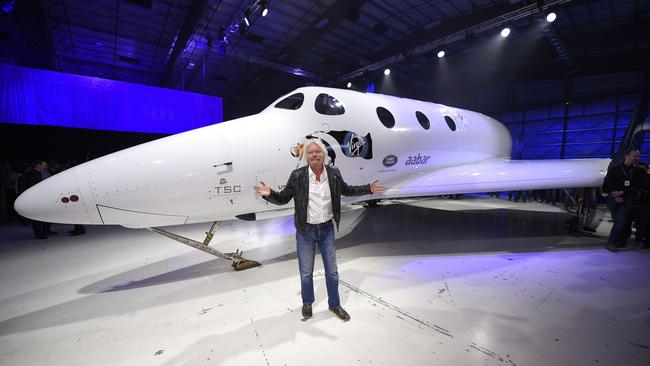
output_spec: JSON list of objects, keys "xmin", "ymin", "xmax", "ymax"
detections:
[{"xmin": 462, "ymin": 72, "xmax": 650, "ymax": 160}]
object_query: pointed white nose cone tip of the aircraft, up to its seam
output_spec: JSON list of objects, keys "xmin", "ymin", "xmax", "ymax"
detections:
[{"xmin": 14, "ymin": 168, "xmax": 101, "ymax": 224}]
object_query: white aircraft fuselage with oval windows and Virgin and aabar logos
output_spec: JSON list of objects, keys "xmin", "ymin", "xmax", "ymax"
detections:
[{"xmin": 16, "ymin": 87, "xmax": 602, "ymax": 227}]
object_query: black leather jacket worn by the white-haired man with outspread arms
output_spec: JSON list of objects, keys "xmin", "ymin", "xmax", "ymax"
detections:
[{"xmin": 264, "ymin": 165, "xmax": 372, "ymax": 232}]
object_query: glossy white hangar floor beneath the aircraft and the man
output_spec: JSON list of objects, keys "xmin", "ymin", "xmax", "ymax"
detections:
[{"xmin": 0, "ymin": 198, "xmax": 650, "ymax": 366}]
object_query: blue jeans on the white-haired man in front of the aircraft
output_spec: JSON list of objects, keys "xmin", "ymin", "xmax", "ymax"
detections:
[{"xmin": 296, "ymin": 221, "xmax": 341, "ymax": 308}]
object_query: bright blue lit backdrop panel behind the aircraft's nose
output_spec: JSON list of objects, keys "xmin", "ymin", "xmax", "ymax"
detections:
[{"xmin": 0, "ymin": 64, "xmax": 223, "ymax": 134}]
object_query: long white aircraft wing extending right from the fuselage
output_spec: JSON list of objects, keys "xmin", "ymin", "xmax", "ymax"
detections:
[{"xmin": 366, "ymin": 159, "xmax": 610, "ymax": 199}]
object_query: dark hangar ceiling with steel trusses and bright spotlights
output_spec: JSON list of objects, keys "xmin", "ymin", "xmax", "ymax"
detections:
[{"xmin": 0, "ymin": 0, "xmax": 650, "ymax": 117}]
